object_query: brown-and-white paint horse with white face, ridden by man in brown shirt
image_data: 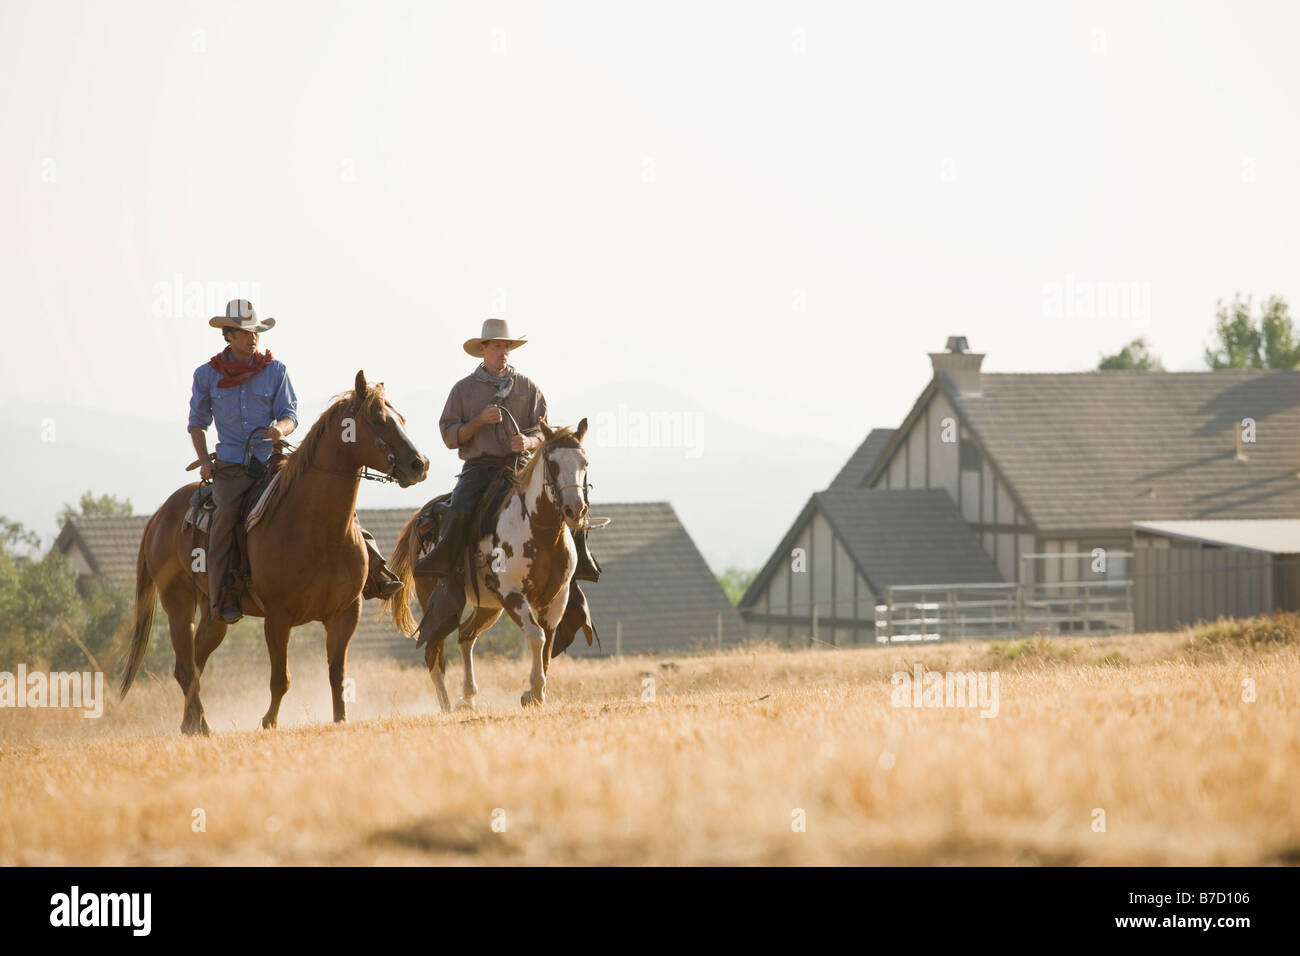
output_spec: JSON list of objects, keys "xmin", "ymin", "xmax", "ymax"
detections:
[{"xmin": 380, "ymin": 419, "xmax": 594, "ymax": 711}]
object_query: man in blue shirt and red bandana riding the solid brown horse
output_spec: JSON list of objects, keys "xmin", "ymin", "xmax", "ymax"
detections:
[{"xmin": 190, "ymin": 299, "xmax": 402, "ymax": 624}]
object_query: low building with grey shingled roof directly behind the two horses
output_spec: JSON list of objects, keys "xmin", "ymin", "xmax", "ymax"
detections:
[{"xmin": 53, "ymin": 502, "xmax": 745, "ymax": 662}]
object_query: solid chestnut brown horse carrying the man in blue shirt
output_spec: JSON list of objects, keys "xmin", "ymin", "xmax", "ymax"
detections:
[{"xmin": 122, "ymin": 372, "xmax": 429, "ymax": 734}]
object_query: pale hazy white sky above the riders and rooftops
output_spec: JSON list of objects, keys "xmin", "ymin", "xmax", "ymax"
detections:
[{"xmin": 0, "ymin": 0, "xmax": 1300, "ymax": 564}]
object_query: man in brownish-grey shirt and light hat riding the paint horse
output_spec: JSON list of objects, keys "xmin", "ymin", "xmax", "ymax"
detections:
[{"xmin": 415, "ymin": 319, "xmax": 601, "ymax": 581}]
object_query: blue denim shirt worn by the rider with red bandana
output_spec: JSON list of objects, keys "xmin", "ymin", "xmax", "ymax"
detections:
[{"xmin": 189, "ymin": 349, "xmax": 298, "ymax": 463}]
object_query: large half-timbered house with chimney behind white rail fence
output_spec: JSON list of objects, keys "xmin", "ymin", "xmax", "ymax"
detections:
[{"xmin": 741, "ymin": 337, "xmax": 1300, "ymax": 643}]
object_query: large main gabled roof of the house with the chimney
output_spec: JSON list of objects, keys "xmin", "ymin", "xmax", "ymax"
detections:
[{"xmin": 867, "ymin": 369, "xmax": 1300, "ymax": 532}]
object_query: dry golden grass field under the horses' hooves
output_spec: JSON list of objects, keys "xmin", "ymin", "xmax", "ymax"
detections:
[{"xmin": 0, "ymin": 619, "xmax": 1300, "ymax": 865}]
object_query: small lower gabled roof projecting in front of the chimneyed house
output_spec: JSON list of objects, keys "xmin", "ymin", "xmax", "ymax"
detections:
[{"xmin": 740, "ymin": 488, "xmax": 1002, "ymax": 607}]
